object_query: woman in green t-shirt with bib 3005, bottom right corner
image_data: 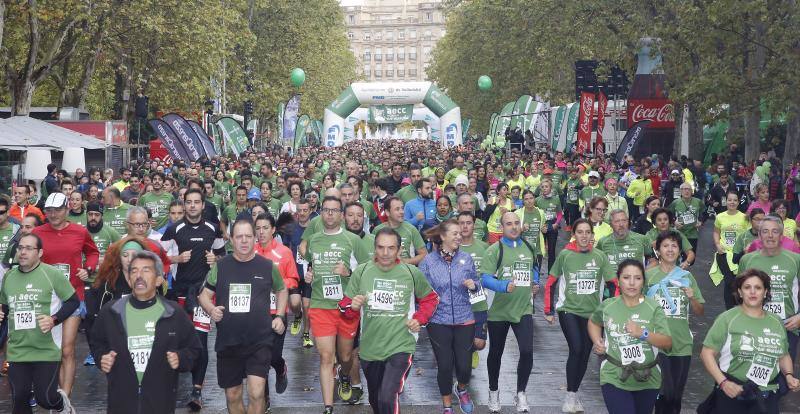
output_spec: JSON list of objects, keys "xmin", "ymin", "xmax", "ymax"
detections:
[{"xmin": 700, "ymin": 269, "xmax": 800, "ymax": 414}]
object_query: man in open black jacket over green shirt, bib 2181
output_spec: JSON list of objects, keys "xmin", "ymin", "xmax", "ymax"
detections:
[{"xmin": 91, "ymin": 250, "xmax": 202, "ymax": 414}]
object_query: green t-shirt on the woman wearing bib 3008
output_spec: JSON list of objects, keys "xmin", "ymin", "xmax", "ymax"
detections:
[{"xmin": 591, "ymin": 296, "xmax": 670, "ymax": 391}]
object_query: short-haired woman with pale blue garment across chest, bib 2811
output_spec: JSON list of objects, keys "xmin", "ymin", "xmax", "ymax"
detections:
[{"xmin": 646, "ymin": 230, "xmax": 705, "ymax": 414}]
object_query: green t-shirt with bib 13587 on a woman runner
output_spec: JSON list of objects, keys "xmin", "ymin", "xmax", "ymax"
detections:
[{"xmin": 549, "ymin": 248, "xmax": 616, "ymax": 318}]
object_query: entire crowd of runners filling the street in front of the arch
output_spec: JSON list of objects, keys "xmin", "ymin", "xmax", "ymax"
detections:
[{"xmin": 0, "ymin": 137, "xmax": 800, "ymax": 414}]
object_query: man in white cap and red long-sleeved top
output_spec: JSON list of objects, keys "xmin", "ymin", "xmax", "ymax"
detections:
[{"xmin": 32, "ymin": 193, "xmax": 100, "ymax": 395}]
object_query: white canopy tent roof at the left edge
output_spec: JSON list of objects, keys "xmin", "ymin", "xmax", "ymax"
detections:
[{"xmin": 0, "ymin": 116, "xmax": 105, "ymax": 151}]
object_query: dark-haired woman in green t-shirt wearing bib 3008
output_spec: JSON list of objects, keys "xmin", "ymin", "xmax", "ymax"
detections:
[{"xmin": 588, "ymin": 259, "xmax": 672, "ymax": 414}]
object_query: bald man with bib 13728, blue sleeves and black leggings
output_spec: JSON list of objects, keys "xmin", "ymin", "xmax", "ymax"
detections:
[{"xmin": 478, "ymin": 211, "xmax": 540, "ymax": 412}]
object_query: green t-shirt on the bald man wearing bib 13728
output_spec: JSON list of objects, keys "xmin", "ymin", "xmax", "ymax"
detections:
[{"xmin": 478, "ymin": 240, "xmax": 539, "ymax": 323}]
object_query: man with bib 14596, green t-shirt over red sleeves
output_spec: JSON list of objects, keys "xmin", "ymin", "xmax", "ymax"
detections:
[{"xmin": 339, "ymin": 228, "xmax": 439, "ymax": 412}]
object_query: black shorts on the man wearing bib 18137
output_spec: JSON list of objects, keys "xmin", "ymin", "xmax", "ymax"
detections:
[{"xmin": 217, "ymin": 344, "xmax": 272, "ymax": 388}]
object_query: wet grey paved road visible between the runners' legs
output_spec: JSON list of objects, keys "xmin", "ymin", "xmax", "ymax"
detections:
[{"xmin": 0, "ymin": 223, "xmax": 800, "ymax": 414}]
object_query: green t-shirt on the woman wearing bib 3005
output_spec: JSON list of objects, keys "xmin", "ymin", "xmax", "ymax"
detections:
[{"xmin": 703, "ymin": 306, "xmax": 789, "ymax": 391}]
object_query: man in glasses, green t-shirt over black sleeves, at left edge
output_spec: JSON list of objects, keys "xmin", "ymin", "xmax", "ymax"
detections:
[{"xmin": 0, "ymin": 234, "xmax": 80, "ymax": 413}]
